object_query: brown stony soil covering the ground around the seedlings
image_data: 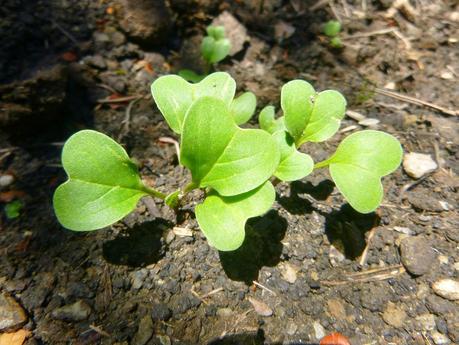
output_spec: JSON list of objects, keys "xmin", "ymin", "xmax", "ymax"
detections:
[{"xmin": 0, "ymin": 0, "xmax": 459, "ymax": 345}]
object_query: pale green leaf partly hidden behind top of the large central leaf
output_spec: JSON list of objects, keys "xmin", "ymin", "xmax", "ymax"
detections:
[{"xmin": 151, "ymin": 72, "xmax": 236, "ymax": 134}]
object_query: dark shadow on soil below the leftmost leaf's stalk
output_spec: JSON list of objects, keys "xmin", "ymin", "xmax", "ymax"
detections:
[{"xmin": 103, "ymin": 218, "xmax": 172, "ymax": 267}]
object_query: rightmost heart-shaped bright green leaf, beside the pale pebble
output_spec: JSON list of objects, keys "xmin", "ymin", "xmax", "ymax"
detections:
[{"xmin": 325, "ymin": 130, "xmax": 403, "ymax": 213}]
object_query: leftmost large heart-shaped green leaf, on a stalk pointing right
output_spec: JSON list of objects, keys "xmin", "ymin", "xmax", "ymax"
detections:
[{"xmin": 53, "ymin": 130, "xmax": 147, "ymax": 231}]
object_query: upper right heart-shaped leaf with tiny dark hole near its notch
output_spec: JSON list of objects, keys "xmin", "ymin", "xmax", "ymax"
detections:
[{"xmin": 281, "ymin": 80, "xmax": 346, "ymax": 147}]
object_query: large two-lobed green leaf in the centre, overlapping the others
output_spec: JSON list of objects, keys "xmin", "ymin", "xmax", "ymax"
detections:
[{"xmin": 180, "ymin": 97, "xmax": 280, "ymax": 196}]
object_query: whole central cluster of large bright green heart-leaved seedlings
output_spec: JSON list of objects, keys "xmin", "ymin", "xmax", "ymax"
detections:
[{"xmin": 54, "ymin": 72, "xmax": 402, "ymax": 251}]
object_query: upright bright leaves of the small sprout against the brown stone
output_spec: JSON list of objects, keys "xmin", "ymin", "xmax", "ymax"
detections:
[{"xmin": 201, "ymin": 25, "xmax": 231, "ymax": 64}]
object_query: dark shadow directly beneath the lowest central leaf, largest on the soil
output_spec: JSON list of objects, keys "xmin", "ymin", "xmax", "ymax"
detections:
[{"xmin": 219, "ymin": 210, "xmax": 287, "ymax": 285}]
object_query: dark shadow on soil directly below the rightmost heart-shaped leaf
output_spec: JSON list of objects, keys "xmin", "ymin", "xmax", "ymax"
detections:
[{"xmin": 322, "ymin": 204, "xmax": 381, "ymax": 260}]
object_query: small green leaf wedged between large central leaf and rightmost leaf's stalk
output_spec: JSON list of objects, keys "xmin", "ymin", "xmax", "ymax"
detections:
[{"xmin": 273, "ymin": 130, "xmax": 314, "ymax": 181}]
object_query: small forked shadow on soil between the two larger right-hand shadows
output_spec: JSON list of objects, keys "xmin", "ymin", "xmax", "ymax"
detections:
[{"xmin": 278, "ymin": 180, "xmax": 335, "ymax": 215}]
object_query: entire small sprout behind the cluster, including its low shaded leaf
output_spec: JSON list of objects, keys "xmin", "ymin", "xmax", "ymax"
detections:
[{"xmin": 179, "ymin": 25, "xmax": 231, "ymax": 83}]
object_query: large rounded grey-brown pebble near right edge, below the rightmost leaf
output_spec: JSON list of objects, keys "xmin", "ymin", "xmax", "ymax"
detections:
[{"xmin": 400, "ymin": 236, "xmax": 436, "ymax": 276}]
